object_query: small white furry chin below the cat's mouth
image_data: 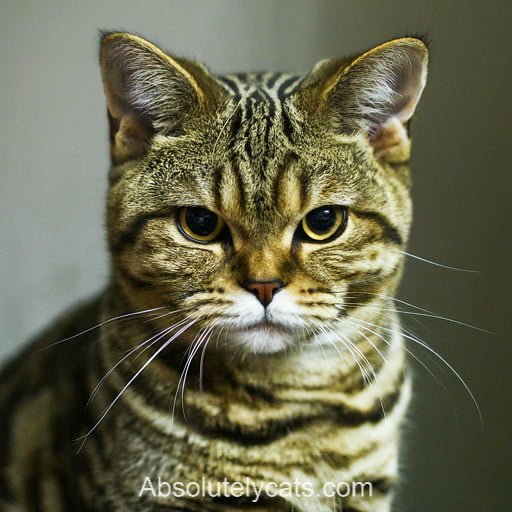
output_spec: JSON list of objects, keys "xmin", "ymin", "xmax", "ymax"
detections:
[{"xmin": 229, "ymin": 325, "xmax": 294, "ymax": 354}]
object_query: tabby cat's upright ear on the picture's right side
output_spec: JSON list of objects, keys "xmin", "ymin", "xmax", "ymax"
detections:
[{"xmin": 300, "ymin": 37, "xmax": 428, "ymax": 160}]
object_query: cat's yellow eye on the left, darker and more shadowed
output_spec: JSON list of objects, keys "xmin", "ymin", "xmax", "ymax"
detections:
[{"xmin": 177, "ymin": 206, "xmax": 224, "ymax": 244}]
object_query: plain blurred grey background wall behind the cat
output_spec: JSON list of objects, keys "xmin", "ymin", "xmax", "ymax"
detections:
[{"xmin": 0, "ymin": 0, "xmax": 512, "ymax": 512}]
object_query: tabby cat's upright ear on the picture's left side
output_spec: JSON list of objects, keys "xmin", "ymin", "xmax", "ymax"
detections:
[{"xmin": 100, "ymin": 33, "xmax": 221, "ymax": 162}]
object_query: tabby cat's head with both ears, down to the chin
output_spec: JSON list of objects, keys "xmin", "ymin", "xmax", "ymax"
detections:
[{"xmin": 100, "ymin": 33, "xmax": 428, "ymax": 352}]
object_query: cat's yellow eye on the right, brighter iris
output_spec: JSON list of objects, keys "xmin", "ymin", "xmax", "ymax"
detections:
[{"xmin": 300, "ymin": 205, "xmax": 347, "ymax": 242}]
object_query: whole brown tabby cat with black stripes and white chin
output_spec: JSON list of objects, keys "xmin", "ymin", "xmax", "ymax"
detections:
[{"xmin": 0, "ymin": 32, "xmax": 428, "ymax": 512}]
